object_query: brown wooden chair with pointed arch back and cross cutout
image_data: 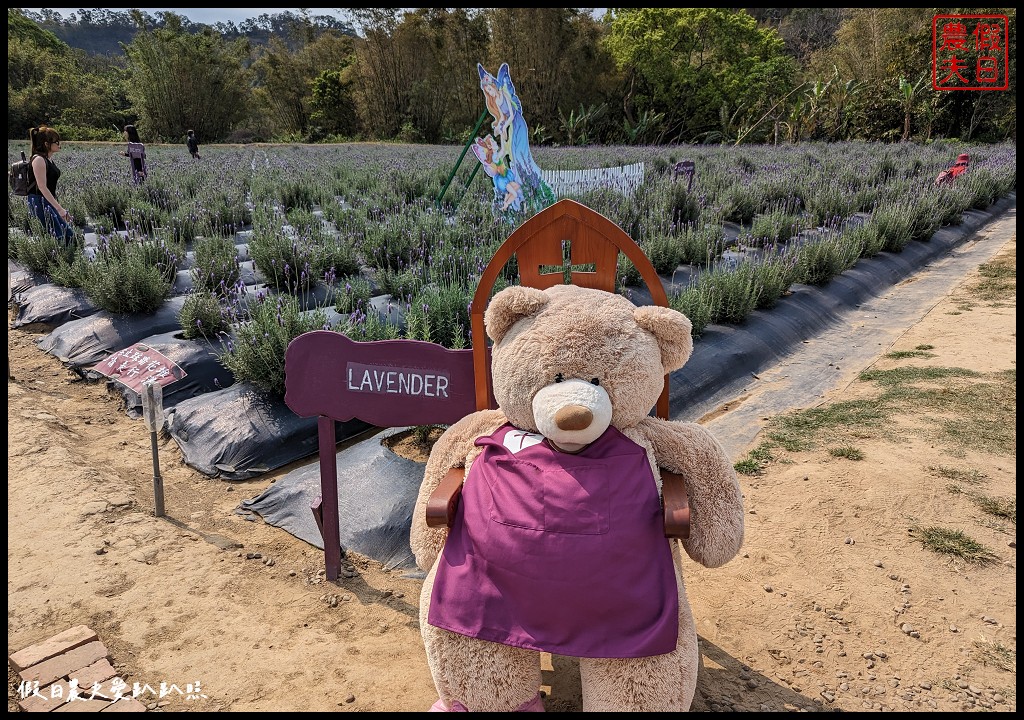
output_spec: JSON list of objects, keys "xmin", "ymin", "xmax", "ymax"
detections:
[{"xmin": 419, "ymin": 200, "xmax": 690, "ymax": 539}]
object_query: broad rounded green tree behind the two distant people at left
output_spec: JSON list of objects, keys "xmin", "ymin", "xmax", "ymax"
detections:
[{"xmin": 124, "ymin": 12, "xmax": 249, "ymax": 141}]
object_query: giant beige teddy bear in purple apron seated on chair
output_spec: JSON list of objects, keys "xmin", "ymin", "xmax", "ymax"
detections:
[{"xmin": 411, "ymin": 285, "xmax": 743, "ymax": 712}]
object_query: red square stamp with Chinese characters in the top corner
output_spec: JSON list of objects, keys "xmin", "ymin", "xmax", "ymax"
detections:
[{"xmin": 932, "ymin": 15, "xmax": 1010, "ymax": 90}]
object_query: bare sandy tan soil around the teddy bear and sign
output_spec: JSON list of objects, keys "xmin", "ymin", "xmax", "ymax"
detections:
[{"xmin": 7, "ymin": 236, "xmax": 1017, "ymax": 712}]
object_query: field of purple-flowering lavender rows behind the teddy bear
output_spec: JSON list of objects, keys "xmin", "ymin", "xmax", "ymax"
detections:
[{"xmin": 8, "ymin": 142, "xmax": 1017, "ymax": 479}]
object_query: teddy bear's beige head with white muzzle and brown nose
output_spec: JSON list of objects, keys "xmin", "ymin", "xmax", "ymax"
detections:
[{"xmin": 483, "ymin": 285, "xmax": 693, "ymax": 452}]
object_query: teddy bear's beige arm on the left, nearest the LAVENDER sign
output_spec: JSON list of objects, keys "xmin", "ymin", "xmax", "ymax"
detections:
[{"xmin": 410, "ymin": 410, "xmax": 505, "ymax": 570}]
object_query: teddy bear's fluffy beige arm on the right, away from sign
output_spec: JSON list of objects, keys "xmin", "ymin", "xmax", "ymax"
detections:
[{"xmin": 642, "ymin": 418, "xmax": 743, "ymax": 567}]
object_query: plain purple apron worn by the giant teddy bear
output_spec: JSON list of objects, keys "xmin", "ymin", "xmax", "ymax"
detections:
[{"xmin": 427, "ymin": 425, "xmax": 679, "ymax": 658}]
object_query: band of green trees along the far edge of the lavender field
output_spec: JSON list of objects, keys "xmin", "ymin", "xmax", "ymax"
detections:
[{"xmin": 8, "ymin": 8, "xmax": 1017, "ymax": 143}]
